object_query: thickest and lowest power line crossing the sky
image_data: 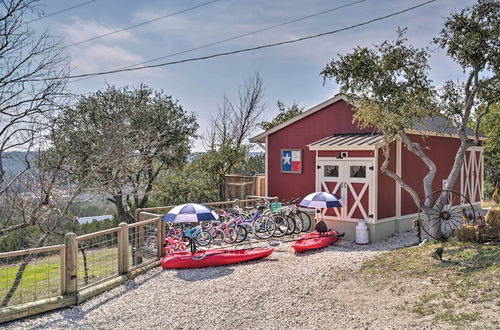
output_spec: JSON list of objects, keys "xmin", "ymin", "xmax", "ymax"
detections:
[{"xmin": 38, "ymin": 0, "xmax": 438, "ymax": 81}]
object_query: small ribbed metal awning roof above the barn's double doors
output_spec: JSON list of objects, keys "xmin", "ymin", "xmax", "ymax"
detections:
[{"xmin": 308, "ymin": 133, "xmax": 383, "ymax": 150}]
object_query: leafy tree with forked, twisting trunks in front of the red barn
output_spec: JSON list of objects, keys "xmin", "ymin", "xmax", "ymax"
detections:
[{"xmin": 322, "ymin": 0, "xmax": 500, "ymax": 236}]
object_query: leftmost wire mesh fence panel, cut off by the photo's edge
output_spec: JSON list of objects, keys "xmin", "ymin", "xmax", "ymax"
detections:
[{"xmin": 0, "ymin": 245, "xmax": 64, "ymax": 307}]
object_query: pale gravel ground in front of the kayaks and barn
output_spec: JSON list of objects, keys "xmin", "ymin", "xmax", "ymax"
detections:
[{"xmin": 4, "ymin": 232, "xmax": 431, "ymax": 329}]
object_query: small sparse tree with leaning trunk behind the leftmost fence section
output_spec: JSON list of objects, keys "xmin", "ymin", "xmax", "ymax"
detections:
[{"xmin": 0, "ymin": 147, "xmax": 81, "ymax": 307}]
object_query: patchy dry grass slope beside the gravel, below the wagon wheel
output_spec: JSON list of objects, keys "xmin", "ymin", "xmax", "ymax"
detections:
[{"xmin": 362, "ymin": 240, "xmax": 500, "ymax": 327}]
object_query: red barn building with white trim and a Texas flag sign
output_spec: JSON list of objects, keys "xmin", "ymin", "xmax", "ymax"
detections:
[{"xmin": 251, "ymin": 95, "xmax": 483, "ymax": 241}]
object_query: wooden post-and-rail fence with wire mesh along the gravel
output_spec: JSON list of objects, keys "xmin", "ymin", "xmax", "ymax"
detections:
[{"xmin": 0, "ymin": 196, "xmax": 277, "ymax": 324}]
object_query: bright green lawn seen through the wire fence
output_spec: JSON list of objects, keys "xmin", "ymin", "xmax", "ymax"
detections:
[{"xmin": 0, "ymin": 248, "xmax": 118, "ymax": 305}]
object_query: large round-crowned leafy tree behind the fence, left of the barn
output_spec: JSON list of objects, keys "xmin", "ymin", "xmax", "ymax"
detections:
[{"xmin": 51, "ymin": 84, "xmax": 198, "ymax": 223}]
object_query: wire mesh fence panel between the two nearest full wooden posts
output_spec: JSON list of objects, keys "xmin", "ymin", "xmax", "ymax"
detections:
[{"xmin": 77, "ymin": 228, "xmax": 120, "ymax": 288}]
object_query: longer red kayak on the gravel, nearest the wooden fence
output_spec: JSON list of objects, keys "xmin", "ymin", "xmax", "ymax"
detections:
[{"xmin": 160, "ymin": 248, "xmax": 274, "ymax": 269}]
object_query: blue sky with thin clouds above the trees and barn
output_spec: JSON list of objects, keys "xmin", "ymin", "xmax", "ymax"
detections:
[{"xmin": 30, "ymin": 0, "xmax": 474, "ymax": 151}]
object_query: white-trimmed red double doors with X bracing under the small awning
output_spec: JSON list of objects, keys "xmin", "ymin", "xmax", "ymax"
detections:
[{"xmin": 316, "ymin": 159, "xmax": 373, "ymax": 220}]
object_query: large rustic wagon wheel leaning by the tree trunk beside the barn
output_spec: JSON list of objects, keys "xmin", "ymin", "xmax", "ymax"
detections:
[{"xmin": 418, "ymin": 190, "xmax": 476, "ymax": 240}]
